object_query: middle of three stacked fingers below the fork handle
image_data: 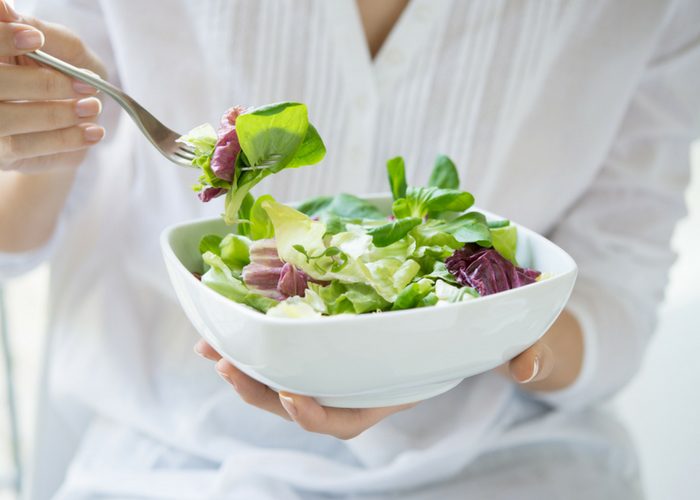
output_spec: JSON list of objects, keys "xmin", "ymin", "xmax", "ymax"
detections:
[{"xmin": 0, "ymin": 97, "xmax": 102, "ymax": 137}]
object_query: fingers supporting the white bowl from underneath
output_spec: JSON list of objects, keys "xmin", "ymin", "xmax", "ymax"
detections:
[{"xmin": 194, "ymin": 340, "xmax": 417, "ymax": 439}]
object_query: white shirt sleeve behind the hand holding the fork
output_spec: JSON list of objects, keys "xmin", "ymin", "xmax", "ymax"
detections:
[{"xmin": 0, "ymin": 0, "xmax": 119, "ymax": 283}]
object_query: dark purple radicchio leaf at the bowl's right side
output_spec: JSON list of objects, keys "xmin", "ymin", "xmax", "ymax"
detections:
[{"xmin": 445, "ymin": 243, "xmax": 540, "ymax": 295}]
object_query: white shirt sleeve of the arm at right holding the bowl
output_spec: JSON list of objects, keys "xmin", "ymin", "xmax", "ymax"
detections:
[{"xmin": 535, "ymin": 1, "xmax": 700, "ymax": 409}]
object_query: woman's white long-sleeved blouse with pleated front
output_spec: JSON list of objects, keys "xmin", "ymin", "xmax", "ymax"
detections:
[{"xmin": 0, "ymin": 0, "xmax": 700, "ymax": 498}]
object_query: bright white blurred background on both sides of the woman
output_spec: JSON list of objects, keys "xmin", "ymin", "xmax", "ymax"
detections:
[{"xmin": 0, "ymin": 141, "xmax": 700, "ymax": 500}]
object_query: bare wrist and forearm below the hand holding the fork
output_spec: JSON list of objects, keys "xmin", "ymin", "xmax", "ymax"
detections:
[{"xmin": 0, "ymin": 168, "xmax": 76, "ymax": 253}]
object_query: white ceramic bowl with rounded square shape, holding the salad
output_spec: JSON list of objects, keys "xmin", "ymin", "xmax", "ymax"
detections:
[{"xmin": 161, "ymin": 193, "xmax": 577, "ymax": 408}]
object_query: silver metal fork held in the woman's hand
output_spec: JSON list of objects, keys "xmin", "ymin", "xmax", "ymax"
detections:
[{"xmin": 25, "ymin": 50, "xmax": 194, "ymax": 167}]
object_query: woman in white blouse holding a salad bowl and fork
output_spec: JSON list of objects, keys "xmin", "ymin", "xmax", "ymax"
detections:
[{"xmin": 0, "ymin": 0, "xmax": 700, "ymax": 499}]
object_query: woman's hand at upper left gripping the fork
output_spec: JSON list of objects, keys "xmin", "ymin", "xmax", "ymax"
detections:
[{"xmin": 0, "ymin": 0, "xmax": 105, "ymax": 173}]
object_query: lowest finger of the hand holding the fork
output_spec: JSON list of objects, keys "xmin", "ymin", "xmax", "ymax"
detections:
[{"xmin": 0, "ymin": 123, "xmax": 105, "ymax": 166}]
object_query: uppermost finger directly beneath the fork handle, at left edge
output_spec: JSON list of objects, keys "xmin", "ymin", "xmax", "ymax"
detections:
[{"xmin": 0, "ymin": 64, "xmax": 97, "ymax": 101}]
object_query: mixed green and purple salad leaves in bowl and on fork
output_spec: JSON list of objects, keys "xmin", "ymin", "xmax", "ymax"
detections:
[{"xmin": 180, "ymin": 102, "xmax": 542, "ymax": 318}]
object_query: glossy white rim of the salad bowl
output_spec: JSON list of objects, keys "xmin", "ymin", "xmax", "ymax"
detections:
[{"xmin": 160, "ymin": 194, "xmax": 578, "ymax": 326}]
